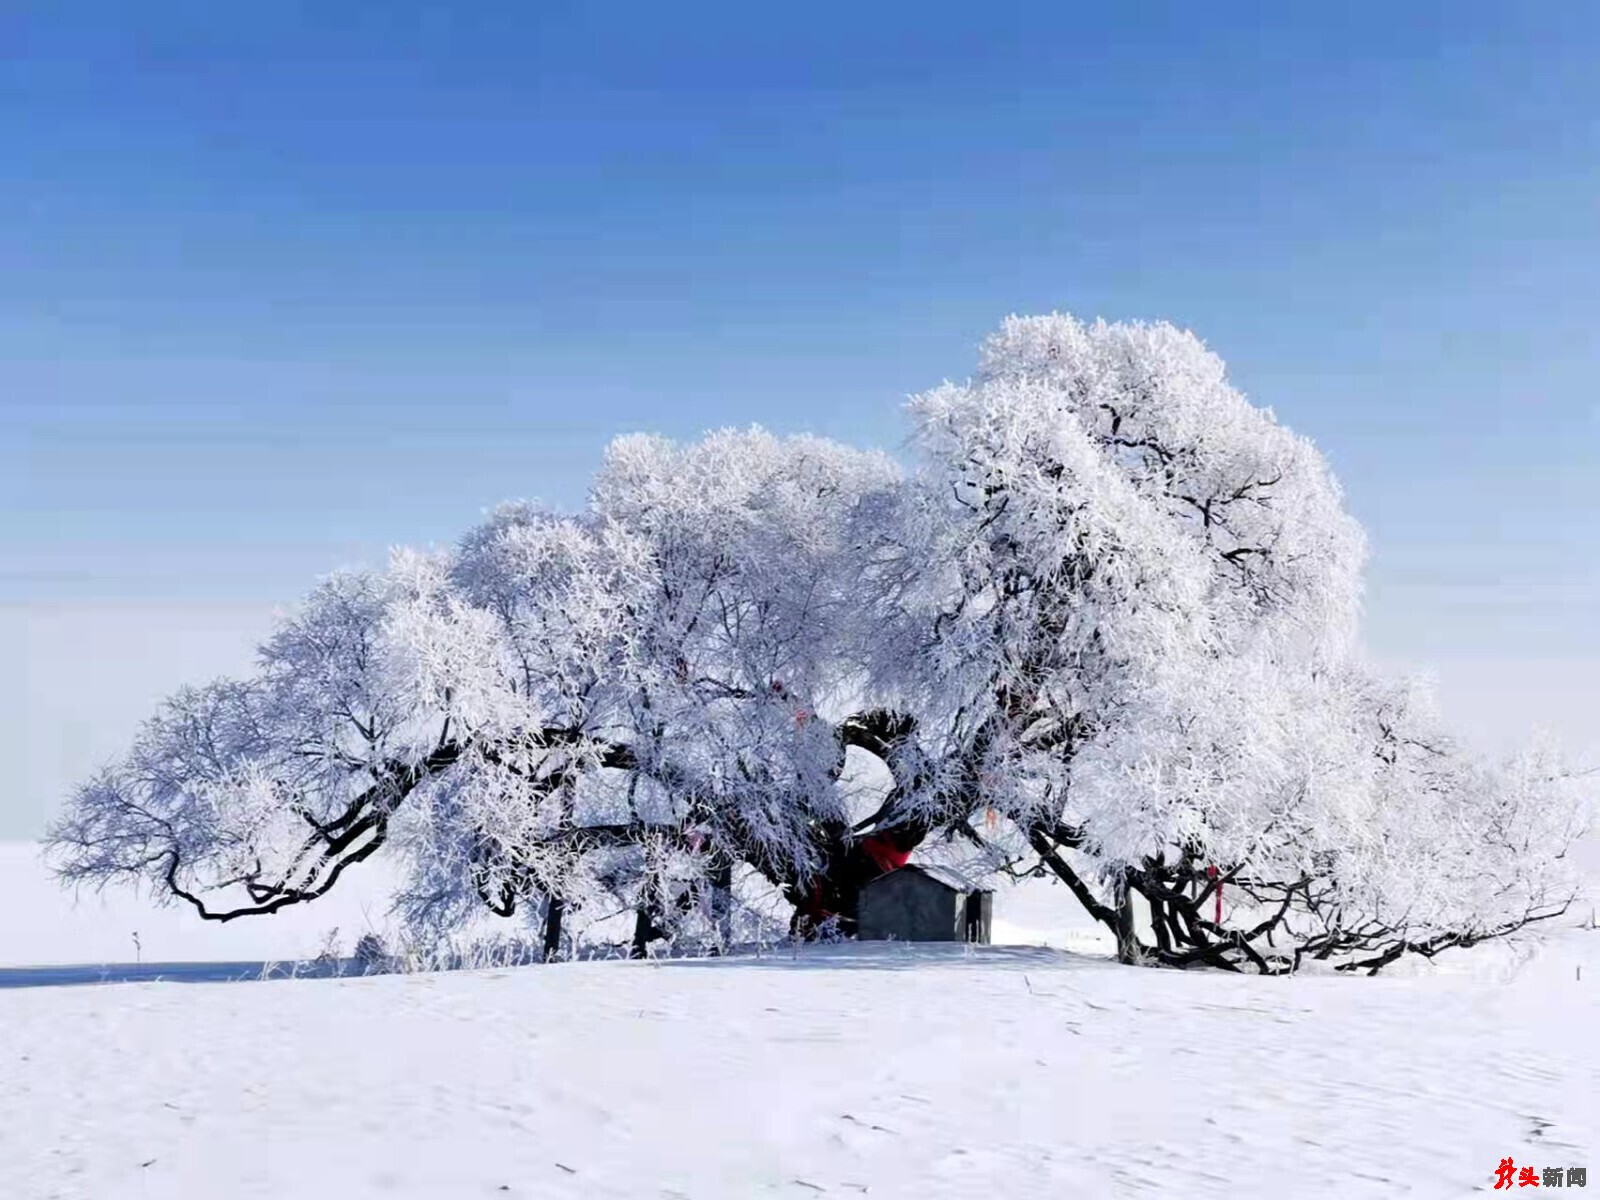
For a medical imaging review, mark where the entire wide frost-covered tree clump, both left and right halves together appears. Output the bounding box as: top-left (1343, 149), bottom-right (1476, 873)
top-left (53, 315), bottom-right (1578, 970)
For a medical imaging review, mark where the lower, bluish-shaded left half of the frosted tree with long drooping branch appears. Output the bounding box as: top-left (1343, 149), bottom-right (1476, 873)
top-left (53, 430), bottom-right (899, 952)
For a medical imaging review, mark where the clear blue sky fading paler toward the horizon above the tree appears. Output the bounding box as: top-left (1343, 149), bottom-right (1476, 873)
top-left (0, 0), bottom-right (1600, 837)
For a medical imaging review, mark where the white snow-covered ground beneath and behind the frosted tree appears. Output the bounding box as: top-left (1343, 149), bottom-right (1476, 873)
top-left (0, 848), bottom-right (1600, 1200)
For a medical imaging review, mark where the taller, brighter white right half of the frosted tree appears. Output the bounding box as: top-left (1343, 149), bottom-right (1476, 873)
top-left (857, 315), bottom-right (1574, 970)
